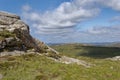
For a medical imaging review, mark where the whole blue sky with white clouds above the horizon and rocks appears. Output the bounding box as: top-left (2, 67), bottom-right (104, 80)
top-left (0, 0), bottom-right (120, 43)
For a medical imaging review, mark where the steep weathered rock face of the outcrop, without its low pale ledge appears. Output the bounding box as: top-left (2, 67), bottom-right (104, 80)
top-left (0, 12), bottom-right (57, 53)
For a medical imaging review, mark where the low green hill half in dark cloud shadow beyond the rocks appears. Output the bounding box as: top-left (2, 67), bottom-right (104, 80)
top-left (51, 44), bottom-right (120, 58)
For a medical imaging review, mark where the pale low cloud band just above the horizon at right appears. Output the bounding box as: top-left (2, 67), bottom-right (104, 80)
top-left (58, 25), bottom-right (120, 43)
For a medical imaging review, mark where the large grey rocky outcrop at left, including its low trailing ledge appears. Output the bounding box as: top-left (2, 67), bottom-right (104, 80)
top-left (0, 12), bottom-right (90, 67)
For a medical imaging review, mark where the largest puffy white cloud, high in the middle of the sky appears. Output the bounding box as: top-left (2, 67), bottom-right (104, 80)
top-left (23, 0), bottom-right (99, 33)
